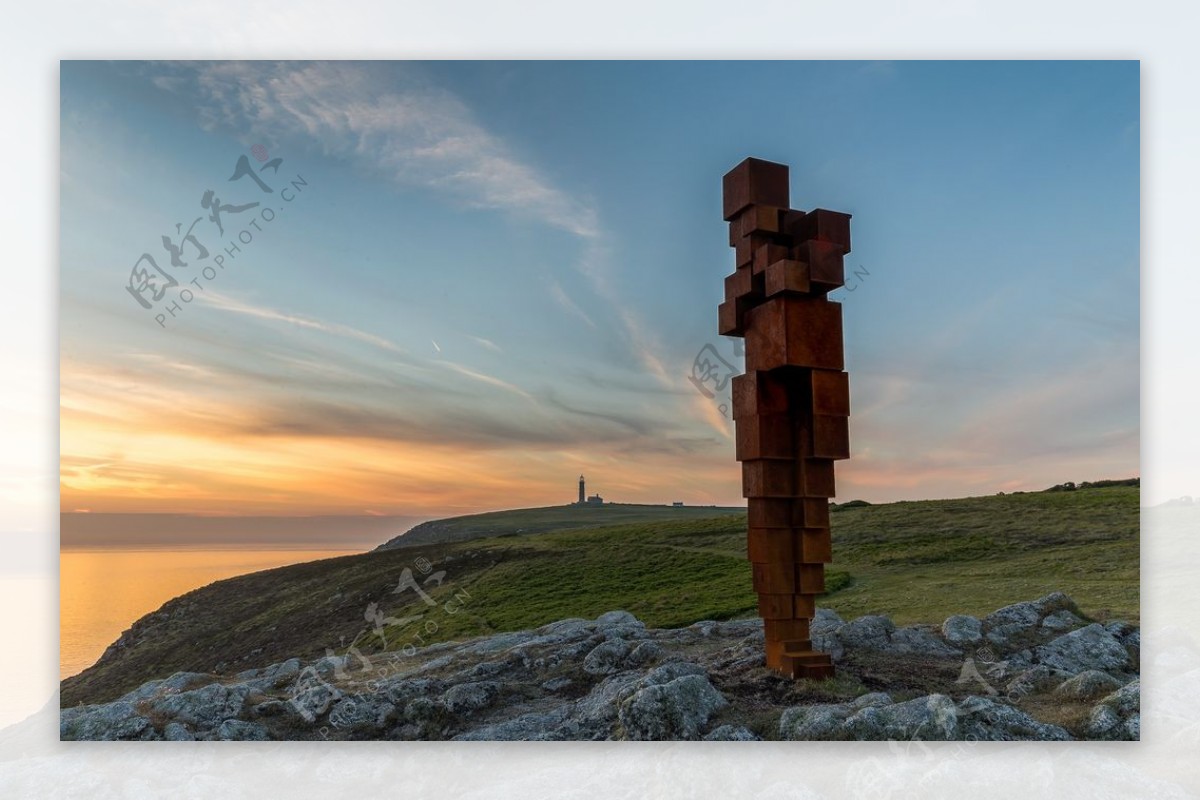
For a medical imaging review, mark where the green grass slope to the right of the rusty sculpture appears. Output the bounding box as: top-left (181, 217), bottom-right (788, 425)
top-left (826, 487), bottom-right (1139, 624)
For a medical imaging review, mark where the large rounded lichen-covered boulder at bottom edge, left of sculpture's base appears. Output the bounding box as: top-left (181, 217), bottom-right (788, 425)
top-left (618, 675), bottom-right (728, 740)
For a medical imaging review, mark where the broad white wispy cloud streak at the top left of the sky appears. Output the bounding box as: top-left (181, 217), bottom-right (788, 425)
top-left (152, 61), bottom-right (598, 237)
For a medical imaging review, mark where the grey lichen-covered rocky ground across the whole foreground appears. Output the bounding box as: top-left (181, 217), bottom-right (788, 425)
top-left (60, 592), bottom-right (1140, 740)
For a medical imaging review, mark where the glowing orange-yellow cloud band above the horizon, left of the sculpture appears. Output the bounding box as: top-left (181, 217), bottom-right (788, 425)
top-left (60, 363), bottom-right (740, 514)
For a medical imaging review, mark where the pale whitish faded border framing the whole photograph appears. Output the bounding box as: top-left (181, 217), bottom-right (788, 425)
top-left (0, 0), bottom-right (1200, 797)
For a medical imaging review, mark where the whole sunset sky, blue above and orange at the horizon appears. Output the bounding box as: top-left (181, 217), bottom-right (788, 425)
top-left (60, 61), bottom-right (1139, 517)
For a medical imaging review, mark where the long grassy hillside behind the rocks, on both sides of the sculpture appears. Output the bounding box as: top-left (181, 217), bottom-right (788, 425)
top-left (62, 487), bottom-right (1139, 705)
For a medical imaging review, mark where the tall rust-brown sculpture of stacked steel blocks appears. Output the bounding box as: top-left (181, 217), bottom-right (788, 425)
top-left (718, 158), bottom-right (850, 679)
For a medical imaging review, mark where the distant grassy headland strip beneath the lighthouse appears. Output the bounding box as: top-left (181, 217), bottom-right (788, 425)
top-left (377, 504), bottom-right (745, 550)
